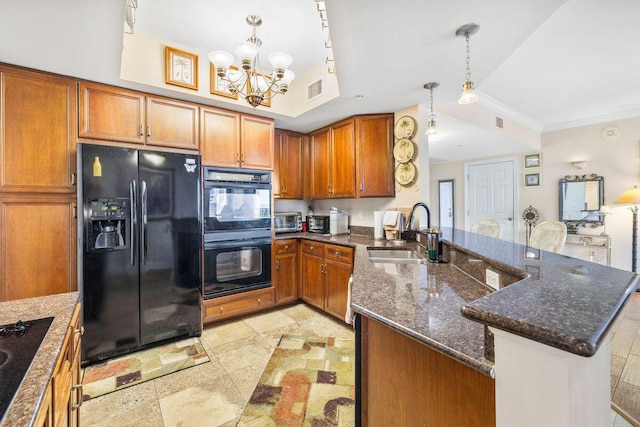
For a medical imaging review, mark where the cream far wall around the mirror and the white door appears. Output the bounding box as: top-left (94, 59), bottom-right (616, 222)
top-left (430, 118), bottom-right (640, 270)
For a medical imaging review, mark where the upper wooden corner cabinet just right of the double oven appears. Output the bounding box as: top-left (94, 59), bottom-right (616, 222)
top-left (272, 129), bottom-right (305, 199)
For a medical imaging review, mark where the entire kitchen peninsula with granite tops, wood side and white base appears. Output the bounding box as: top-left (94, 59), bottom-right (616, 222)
top-left (279, 230), bottom-right (639, 427)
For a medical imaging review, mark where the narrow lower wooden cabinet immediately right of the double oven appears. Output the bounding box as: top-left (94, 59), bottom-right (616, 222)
top-left (271, 239), bottom-right (298, 304)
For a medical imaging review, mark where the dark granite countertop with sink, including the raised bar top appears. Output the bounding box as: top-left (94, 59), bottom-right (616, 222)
top-left (276, 229), bottom-right (640, 375)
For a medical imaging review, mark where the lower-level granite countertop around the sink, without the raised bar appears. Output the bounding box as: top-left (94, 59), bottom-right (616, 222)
top-left (276, 233), bottom-right (493, 376)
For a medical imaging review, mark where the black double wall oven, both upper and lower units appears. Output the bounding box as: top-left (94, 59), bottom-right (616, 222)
top-left (202, 167), bottom-right (271, 299)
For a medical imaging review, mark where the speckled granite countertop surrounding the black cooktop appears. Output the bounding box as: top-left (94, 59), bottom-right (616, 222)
top-left (0, 292), bottom-right (79, 427)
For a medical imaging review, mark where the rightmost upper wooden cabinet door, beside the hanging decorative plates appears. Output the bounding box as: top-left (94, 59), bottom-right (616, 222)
top-left (356, 114), bottom-right (395, 197)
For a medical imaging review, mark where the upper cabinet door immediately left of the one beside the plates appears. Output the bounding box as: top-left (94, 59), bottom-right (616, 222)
top-left (330, 119), bottom-right (356, 198)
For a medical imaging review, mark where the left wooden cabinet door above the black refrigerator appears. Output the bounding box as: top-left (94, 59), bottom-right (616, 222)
top-left (78, 83), bottom-right (145, 144)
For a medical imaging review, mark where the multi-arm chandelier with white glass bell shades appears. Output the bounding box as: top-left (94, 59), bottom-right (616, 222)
top-left (209, 15), bottom-right (295, 108)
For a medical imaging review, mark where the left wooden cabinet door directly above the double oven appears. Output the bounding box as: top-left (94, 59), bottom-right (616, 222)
top-left (200, 108), bottom-right (240, 168)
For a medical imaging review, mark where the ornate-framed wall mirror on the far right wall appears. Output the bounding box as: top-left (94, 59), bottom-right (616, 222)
top-left (558, 174), bottom-right (604, 233)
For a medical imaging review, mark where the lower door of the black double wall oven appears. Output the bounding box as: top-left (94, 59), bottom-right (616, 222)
top-left (204, 238), bottom-right (271, 299)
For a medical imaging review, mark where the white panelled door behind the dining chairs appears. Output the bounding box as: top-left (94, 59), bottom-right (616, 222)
top-left (465, 157), bottom-right (518, 241)
